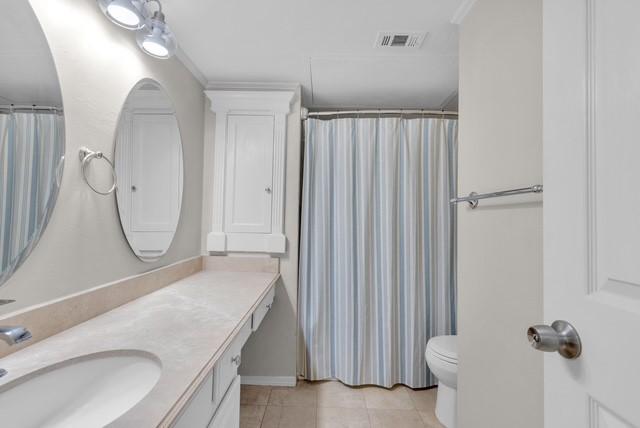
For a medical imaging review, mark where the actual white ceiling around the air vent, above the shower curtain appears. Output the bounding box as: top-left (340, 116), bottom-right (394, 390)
top-left (162, 0), bottom-right (469, 109)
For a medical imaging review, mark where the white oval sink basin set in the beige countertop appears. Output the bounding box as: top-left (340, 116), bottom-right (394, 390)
top-left (0, 351), bottom-right (162, 428)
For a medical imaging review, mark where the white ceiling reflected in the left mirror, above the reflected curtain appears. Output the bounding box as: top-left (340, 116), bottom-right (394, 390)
top-left (0, 0), bottom-right (62, 106)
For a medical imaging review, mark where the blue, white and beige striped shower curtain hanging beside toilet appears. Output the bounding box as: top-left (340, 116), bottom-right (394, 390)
top-left (298, 118), bottom-right (457, 388)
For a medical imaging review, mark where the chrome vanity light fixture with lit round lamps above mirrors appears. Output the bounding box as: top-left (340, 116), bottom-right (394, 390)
top-left (98, 0), bottom-right (178, 59)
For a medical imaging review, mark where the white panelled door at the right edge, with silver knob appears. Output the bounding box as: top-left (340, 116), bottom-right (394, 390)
top-left (543, 0), bottom-right (640, 428)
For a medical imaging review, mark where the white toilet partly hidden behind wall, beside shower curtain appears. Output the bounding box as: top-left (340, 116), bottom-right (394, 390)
top-left (425, 336), bottom-right (458, 428)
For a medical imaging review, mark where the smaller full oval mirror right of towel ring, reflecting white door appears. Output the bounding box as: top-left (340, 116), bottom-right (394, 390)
top-left (115, 79), bottom-right (183, 262)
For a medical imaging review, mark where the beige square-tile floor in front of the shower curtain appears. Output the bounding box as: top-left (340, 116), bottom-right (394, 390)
top-left (240, 382), bottom-right (443, 428)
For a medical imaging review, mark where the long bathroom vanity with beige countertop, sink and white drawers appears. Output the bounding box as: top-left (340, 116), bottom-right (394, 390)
top-left (0, 257), bottom-right (279, 428)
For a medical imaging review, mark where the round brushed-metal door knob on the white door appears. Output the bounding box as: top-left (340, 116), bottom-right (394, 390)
top-left (527, 320), bottom-right (582, 360)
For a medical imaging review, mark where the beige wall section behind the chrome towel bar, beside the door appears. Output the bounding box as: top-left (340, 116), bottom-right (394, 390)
top-left (458, 0), bottom-right (543, 428)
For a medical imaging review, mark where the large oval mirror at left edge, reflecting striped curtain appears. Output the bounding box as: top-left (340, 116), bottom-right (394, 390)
top-left (0, 0), bottom-right (65, 290)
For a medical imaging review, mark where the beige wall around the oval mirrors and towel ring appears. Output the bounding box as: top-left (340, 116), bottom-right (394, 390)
top-left (0, 0), bottom-right (204, 313)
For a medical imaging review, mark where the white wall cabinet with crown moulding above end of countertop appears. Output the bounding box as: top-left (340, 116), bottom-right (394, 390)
top-left (205, 91), bottom-right (295, 253)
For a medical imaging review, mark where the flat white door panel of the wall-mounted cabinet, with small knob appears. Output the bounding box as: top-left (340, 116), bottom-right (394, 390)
top-left (225, 115), bottom-right (274, 233)
